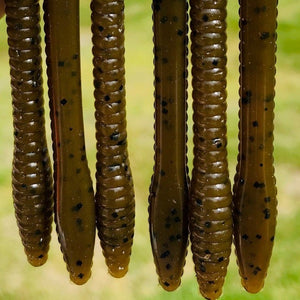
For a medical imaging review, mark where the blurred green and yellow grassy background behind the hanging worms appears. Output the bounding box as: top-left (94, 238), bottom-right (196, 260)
top-left (0, 0), bottom-right (300, 300)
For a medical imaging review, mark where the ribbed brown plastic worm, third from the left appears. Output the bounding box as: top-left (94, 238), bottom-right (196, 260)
top-left (91, 0), bottom-right (135, 277)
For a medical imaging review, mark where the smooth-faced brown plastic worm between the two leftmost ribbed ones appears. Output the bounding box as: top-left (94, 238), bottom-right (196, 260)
top-left (44, 0), bottom-right (95, 284)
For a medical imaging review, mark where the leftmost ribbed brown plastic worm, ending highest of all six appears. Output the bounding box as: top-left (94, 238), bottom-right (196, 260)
top-left (6, 0), bottom-right (53, 266)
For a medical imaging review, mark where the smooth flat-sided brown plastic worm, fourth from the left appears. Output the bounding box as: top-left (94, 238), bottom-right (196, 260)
top-left (149, 0), bottom-right (189, 291)
